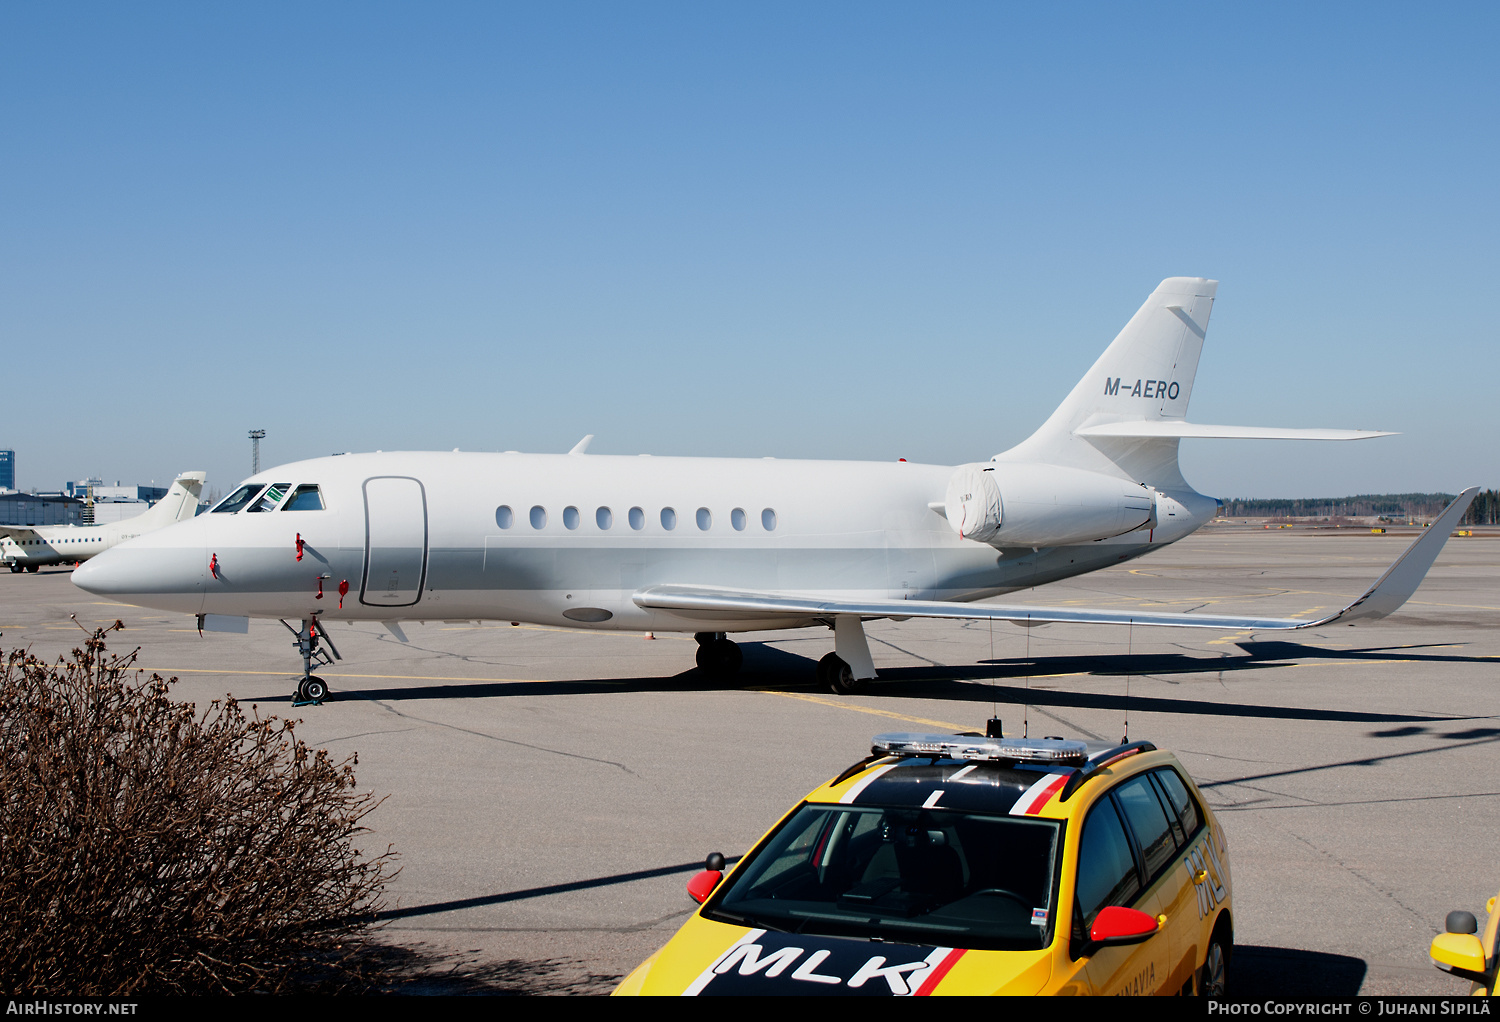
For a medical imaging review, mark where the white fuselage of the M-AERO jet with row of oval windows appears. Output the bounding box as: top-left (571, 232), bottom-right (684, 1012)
top-left (75, 452), bottom-right (1215, 632)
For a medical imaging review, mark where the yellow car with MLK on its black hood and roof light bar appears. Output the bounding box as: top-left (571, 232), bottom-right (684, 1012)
top-left (615, 720), bottom-right (1233, 995)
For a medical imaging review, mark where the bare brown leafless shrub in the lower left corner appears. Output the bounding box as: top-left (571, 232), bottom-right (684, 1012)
top-left (0, 621), bottom-right (393, 995)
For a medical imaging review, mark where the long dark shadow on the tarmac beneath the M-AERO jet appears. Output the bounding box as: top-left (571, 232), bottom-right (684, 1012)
top-left (252, 642), bottom-right (1494, 725)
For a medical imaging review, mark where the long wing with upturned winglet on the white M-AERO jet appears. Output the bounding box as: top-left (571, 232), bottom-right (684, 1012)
top-left (635, 486), bottom-right (1479, 632)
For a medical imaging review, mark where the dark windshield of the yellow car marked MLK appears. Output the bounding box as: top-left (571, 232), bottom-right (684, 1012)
top-left (704, 804), bottom-right (1061, 950)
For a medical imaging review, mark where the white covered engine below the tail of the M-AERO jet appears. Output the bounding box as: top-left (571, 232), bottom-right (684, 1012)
top-left (945, 462), bottom-right (1157, 546)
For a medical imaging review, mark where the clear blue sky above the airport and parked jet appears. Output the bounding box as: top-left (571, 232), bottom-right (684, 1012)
top-left (0, 3), bottom-right (1500, 497)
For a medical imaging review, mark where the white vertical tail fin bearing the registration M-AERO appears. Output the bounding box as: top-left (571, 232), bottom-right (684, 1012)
top-left (998, 276), bottom-right (1218, 489)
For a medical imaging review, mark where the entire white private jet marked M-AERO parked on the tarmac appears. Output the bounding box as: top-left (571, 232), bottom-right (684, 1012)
top-left (74, 278), bottom-right (1475, 701)
